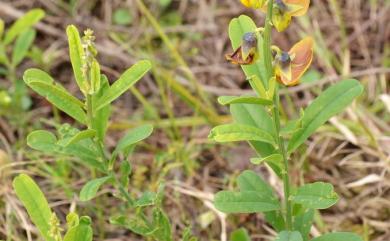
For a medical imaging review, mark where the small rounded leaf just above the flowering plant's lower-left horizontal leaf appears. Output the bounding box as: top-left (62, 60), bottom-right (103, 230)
top-left (237, 170), bottom-right (274, 197)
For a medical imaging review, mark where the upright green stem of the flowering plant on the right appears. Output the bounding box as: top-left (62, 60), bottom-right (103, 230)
top-left (263, 0), bottom-right (292, 230)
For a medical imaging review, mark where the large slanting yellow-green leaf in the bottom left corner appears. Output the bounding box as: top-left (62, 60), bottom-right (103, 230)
top-left (13, 174), bottom-right (54, 241)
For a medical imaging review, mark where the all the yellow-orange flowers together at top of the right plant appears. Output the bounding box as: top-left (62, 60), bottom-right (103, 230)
top-left (226, 0), bottom-right (313, 86)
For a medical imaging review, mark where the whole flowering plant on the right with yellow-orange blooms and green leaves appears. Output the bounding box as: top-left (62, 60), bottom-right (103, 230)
top-left (209, 0), bottom-right (363, 241)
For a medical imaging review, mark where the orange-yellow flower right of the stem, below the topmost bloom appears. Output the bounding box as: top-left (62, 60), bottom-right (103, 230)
top-left (275, 37), bottom-right (313, 86)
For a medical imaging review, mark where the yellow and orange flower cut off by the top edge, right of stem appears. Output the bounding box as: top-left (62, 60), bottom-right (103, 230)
top-left (262, 0), bottom-right (310, 32)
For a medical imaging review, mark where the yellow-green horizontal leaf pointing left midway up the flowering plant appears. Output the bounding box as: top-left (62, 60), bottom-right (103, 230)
top-left (209, 124), bottom-right (275, 144)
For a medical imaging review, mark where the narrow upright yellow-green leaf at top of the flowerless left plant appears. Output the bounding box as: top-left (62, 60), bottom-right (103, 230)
top-left (66, 25), bottom-right (87, 94)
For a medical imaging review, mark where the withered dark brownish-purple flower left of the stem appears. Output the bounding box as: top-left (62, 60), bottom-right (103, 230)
top-left (225, 32), bottom-right (258, 65)
